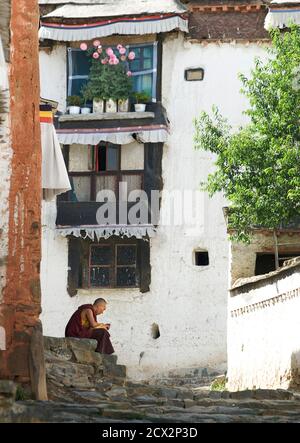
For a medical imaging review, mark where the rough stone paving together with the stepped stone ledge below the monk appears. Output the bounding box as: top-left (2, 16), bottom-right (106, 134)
top-left (0, 338), bottom-right (300, 423)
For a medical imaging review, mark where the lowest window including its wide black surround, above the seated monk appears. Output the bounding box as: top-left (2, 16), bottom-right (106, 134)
top-left (68, 236), bottom-right (151, 296)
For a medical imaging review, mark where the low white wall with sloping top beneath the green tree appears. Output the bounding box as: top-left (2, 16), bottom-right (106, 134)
top-left (228, 259), bottom-right (300, 391)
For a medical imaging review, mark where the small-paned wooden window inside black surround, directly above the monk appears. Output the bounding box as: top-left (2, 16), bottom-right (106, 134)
top-left (89, 242), bottom-right (138, 288)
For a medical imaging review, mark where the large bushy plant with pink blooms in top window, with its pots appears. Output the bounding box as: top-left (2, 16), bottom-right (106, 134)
top-left (80, 40), bottom-right (135, 112)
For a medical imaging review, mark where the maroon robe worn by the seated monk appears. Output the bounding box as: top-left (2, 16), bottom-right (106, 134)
top-left (65, 305), bottom-right (114, 354)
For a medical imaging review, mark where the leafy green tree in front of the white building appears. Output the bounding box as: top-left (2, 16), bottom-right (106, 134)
top-left (194, 26), bottom-right (300, 265)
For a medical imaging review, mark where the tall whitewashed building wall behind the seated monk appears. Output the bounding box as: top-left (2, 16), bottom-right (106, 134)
top-left (41, 35), bottom-right (264, 379)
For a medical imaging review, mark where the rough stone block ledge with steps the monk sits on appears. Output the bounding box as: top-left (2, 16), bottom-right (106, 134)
top-left (44, 337), bottom-right (126, 397)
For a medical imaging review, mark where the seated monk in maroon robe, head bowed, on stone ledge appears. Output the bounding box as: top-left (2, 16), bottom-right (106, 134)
top-left (65, 298), bottom-right (114, 354)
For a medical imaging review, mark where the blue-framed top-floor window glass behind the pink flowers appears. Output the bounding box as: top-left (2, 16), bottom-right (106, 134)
top-left (68, 42), bottom-right (157, 101)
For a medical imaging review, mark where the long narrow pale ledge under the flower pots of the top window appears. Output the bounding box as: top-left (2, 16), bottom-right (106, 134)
top-left (58, 112), bottom-right (155, 123)
